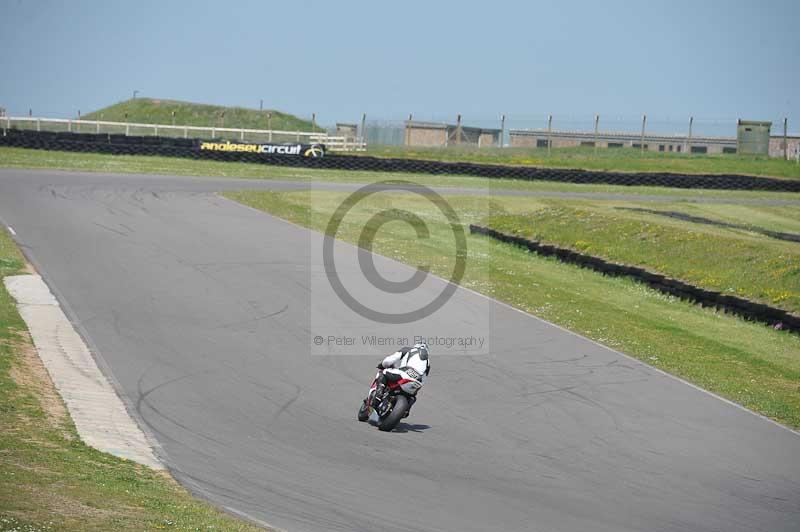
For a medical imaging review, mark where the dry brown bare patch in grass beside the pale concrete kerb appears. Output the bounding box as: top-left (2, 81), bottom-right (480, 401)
top-left (9, 331), bottom-right (72, 440)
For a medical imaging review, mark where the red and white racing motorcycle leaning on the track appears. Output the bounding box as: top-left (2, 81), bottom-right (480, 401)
top-left (358, 367), bottom-right (422, 432)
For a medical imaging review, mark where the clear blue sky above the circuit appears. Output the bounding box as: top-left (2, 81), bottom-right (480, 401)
top-left (0, 0), bottom-right (800, 130)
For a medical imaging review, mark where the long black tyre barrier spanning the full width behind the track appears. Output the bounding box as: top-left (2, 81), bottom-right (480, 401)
top-left (0, 129), bottom-right (800, 192)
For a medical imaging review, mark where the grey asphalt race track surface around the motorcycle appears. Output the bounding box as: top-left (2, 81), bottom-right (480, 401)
top-left (0, 170), bottom-right (800, 532)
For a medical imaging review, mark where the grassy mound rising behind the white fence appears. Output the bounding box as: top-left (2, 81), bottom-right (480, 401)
top-left (82, 98), bottom-right (323, 131)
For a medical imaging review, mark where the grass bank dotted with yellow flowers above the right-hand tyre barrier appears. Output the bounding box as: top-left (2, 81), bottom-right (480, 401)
top-left (482, 201), bottom-right (800, 312)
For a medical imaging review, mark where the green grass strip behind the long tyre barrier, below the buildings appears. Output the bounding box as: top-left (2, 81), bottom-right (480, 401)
top-left (361, 146), bottom-right (800, 179)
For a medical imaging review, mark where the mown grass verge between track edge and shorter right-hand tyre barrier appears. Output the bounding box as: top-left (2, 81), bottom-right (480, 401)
top-left (226, 191), bottom-right (800, 428)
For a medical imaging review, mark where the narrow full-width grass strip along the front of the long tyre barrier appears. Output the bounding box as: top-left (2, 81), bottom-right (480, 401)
top-left (0, 147), bottom-right (800, 201)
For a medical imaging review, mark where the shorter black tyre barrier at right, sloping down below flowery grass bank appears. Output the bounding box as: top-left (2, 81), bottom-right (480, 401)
top-left (469, 224), bottom-right (800, 332)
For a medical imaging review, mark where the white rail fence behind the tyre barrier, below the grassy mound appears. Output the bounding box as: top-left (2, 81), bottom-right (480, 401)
top-left (0, 116), bottom-right (366, 151)
